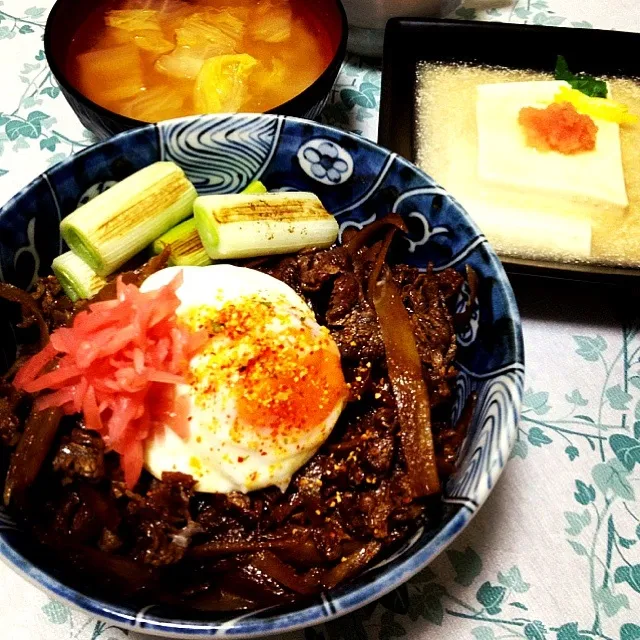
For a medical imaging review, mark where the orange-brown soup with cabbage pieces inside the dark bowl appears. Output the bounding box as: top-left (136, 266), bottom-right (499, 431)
top-left (67, 0), bottom-right (335, 122)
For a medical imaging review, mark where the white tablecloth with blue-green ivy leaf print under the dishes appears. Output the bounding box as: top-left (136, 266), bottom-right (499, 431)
top-left (0, 0), bottom-right (640, 640)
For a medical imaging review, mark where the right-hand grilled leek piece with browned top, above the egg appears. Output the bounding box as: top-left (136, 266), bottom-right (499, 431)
top-left (193, 192), bottom-right (338, 260)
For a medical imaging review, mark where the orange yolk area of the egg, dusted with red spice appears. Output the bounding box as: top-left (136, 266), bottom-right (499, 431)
top-left (185, 296), bottom-right (348, 437)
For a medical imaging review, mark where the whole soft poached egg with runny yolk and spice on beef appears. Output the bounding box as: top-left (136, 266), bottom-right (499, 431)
top-left (140, 264), bottom-right (348, 493)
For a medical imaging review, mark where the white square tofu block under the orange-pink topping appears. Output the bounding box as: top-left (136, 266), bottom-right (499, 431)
top-left (476, 81), bottom-right (629, 220)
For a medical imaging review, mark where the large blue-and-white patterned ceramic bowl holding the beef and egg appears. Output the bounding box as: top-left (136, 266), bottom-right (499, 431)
top-left (0, 115), bottom-right (524, 638)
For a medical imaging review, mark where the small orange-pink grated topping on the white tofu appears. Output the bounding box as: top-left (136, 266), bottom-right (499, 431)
top-left (518, 102), bottom-right (598, 155)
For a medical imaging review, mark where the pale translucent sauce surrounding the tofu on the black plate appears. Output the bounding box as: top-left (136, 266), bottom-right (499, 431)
top-left (415, 63), bottom-right (640, 267)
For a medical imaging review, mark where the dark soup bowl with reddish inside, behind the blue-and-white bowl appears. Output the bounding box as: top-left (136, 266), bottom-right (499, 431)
top-left (44, 0), bottom-right (348, 139)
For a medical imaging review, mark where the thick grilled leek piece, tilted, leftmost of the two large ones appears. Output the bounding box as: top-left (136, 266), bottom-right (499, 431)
top-left (60, 162), bottom-right (197, 277)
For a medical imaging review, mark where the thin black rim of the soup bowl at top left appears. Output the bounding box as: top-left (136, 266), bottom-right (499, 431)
top-left (43, 0), bottom-right (349, 130)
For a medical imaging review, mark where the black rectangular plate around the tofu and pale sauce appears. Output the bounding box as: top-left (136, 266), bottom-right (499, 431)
top-left (378, 18), bottom-right (640, 283)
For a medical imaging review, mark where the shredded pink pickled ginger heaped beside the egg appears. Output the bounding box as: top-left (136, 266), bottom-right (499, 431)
top-left (13, 275), bottom-right (206, 489)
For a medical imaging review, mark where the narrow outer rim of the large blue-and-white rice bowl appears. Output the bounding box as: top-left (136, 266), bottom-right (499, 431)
top-left (0, 113), bottom-right (525, 639)
